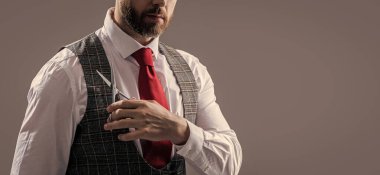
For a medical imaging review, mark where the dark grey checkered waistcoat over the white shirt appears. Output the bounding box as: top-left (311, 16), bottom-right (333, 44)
top-left (66, 33), bottom-right (198, 175)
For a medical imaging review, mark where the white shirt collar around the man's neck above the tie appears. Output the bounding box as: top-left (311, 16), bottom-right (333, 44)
top-left (104, 7), bottom-right (159, 60)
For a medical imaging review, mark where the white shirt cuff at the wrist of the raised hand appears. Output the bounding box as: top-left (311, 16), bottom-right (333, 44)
top-left (174, 121), bottom-right (204, 161)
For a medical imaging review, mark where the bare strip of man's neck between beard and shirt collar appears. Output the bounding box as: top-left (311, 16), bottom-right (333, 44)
top-left (112, 9), bottom-right (154, 46)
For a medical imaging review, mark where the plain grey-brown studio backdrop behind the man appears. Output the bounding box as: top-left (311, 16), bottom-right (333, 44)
top-left (0, 0), bottom-right (380, 175)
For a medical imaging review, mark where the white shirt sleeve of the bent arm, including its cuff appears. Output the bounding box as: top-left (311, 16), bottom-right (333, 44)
top-left (176, 51), bottom-right (242, 175)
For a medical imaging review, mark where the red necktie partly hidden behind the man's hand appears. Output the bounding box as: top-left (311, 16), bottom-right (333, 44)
top-left (132, 48), bottom-right (172, 169)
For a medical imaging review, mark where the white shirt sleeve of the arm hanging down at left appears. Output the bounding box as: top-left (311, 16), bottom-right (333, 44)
top-left (11, 55), bottom-right (75, 175)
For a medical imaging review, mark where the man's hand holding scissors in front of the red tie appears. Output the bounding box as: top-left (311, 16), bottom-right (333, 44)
top-left (104, 99), bottom-right (190, 145)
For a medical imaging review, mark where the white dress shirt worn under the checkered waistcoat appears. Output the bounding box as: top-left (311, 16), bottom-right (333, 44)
top-left (11, 8), bottom-right (242, 175)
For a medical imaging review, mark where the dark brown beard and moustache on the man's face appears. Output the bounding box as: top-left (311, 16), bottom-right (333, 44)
top-left (122, 5), bottom-right (170, 37)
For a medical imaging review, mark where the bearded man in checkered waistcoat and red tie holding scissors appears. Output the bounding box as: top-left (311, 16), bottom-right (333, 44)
top-left (11, 0), bottom-right (242, 175)
